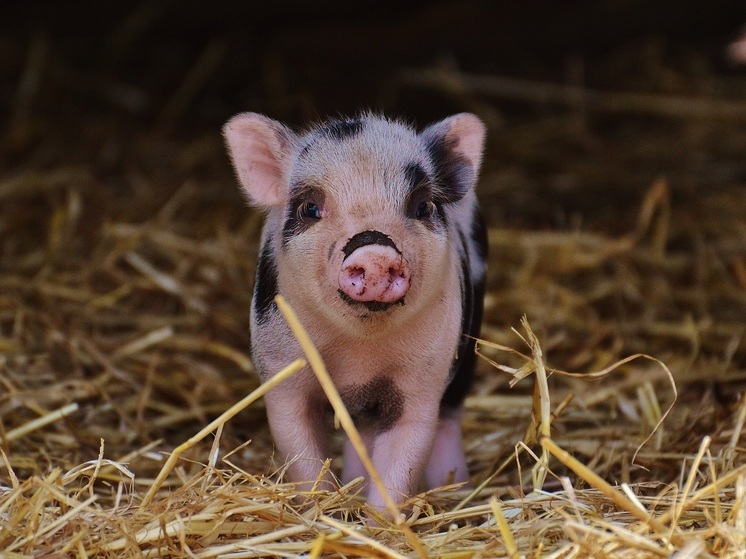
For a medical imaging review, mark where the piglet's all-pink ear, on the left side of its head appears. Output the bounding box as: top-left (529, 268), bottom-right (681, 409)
top-left (223, 113), bottom-right (296, 209)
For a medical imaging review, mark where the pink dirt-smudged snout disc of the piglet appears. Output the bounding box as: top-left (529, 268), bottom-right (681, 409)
top-left (339, 244), bottom-right (412, 303)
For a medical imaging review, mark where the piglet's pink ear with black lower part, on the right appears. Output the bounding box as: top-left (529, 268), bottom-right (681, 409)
top-left (422, 113), bottom-right (486, 203)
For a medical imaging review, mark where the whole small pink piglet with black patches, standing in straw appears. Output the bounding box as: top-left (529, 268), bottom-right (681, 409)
top-left (224, 113), bottom-right (486, 507)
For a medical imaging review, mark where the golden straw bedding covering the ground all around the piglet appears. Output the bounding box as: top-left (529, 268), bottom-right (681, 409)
top-left (0, 3), bottom-right (746, 559)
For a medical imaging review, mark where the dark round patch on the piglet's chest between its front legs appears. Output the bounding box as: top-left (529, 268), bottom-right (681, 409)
top-left (340, 377), bottom-right (405, 432)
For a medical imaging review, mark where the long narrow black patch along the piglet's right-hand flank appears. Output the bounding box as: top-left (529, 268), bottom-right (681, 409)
top-left (440, 230), bottom-right (484, 416)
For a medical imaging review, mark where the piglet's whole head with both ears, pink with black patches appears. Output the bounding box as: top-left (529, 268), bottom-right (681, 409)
top-left (224, 113), bottom-right (484, 329)
